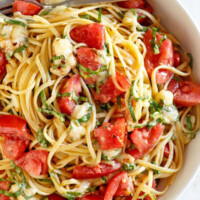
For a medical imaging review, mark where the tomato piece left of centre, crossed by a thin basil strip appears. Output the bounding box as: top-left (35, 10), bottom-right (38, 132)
top-left (58, 75), bottom-right (82, 114)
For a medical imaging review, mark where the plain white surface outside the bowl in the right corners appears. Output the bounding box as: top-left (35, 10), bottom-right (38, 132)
top-left (177, 0), bottom-right (200, 200)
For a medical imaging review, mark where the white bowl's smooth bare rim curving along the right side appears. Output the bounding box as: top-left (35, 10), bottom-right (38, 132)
top-left (149, 0), bottom-right (200, 200)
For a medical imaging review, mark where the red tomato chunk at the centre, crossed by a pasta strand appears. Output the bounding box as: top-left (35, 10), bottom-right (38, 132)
top-left (94, 72), bottom-right (130, 103)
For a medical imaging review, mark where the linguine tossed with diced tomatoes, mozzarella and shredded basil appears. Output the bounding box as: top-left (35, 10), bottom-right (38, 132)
top-left (0, 0), bottom-right (200, 200)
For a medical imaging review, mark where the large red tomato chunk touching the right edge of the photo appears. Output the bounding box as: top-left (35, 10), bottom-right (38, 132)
top-left (168, 79), bottom-right (200, 107)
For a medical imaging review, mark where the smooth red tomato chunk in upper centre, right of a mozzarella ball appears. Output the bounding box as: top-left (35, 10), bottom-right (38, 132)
top-left (70, 23), bottom-right (105, 49)
